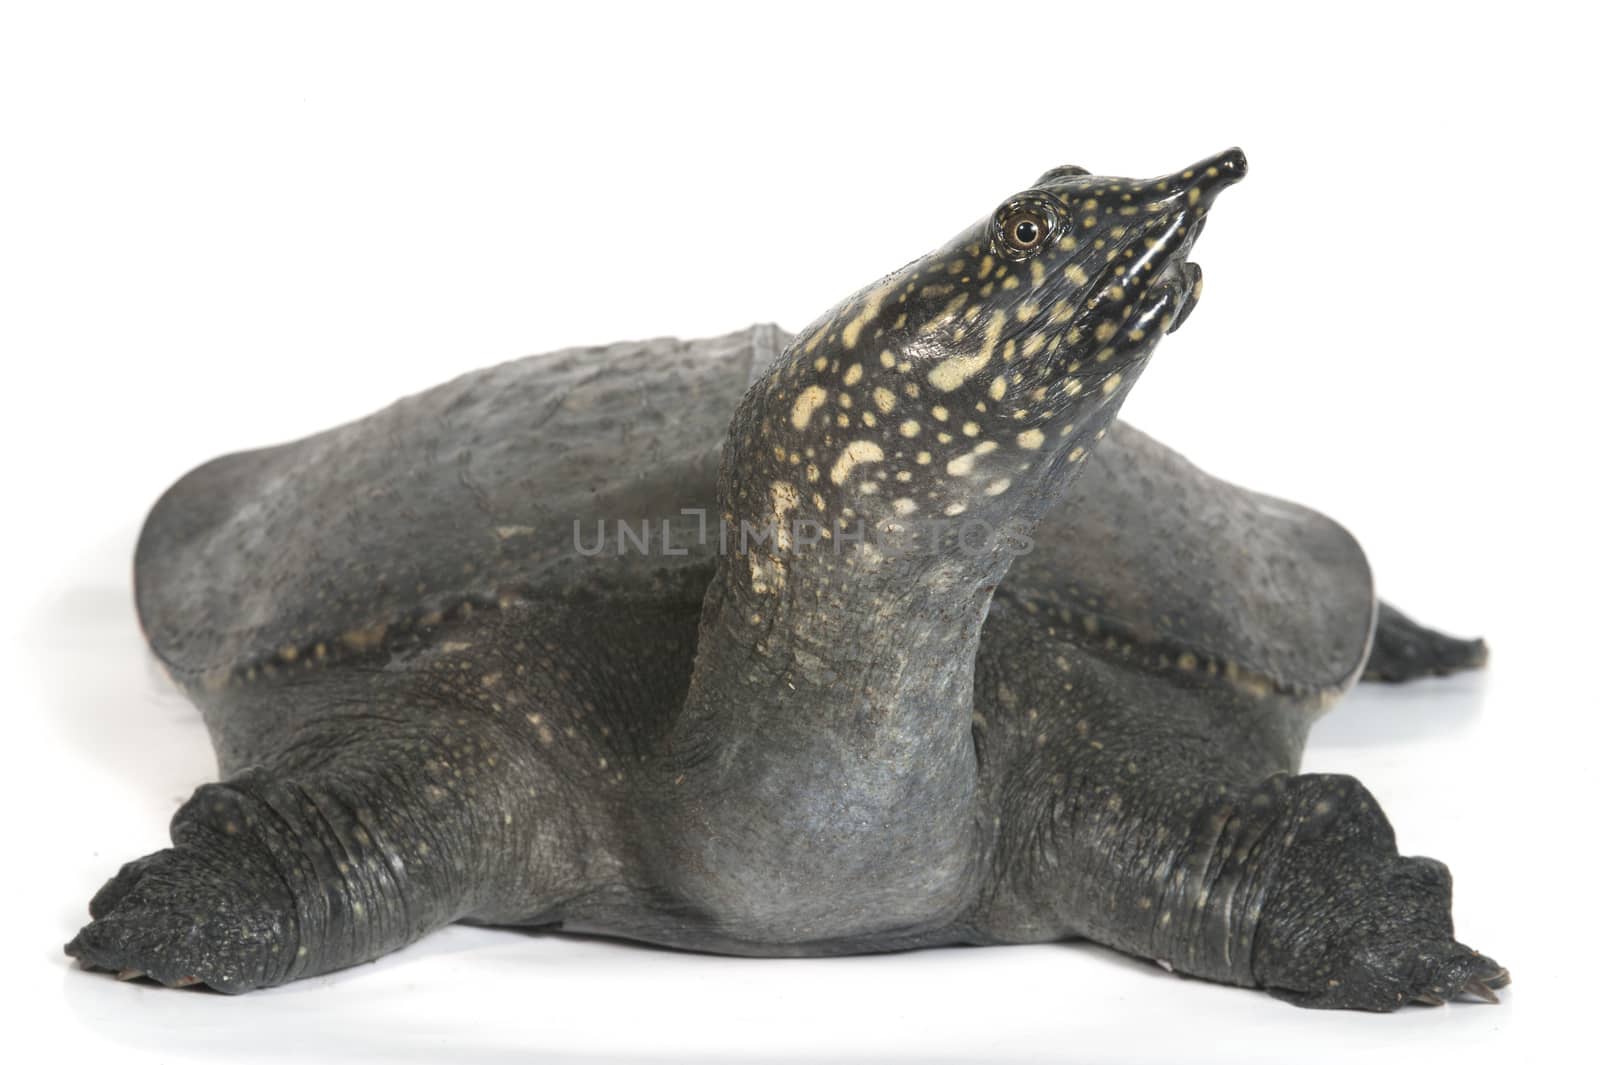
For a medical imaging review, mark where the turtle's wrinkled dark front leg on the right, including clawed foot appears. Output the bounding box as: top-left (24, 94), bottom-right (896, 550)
top-left (982, 667), bottom-right (1509, 1011)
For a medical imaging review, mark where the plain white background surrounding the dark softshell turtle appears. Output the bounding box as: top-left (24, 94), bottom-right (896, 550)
top-left (0, 2), bottom-right (1600, 1062)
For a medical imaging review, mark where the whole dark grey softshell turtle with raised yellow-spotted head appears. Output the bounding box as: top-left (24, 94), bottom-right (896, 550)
top-left (67, 150), bottom-right (1509, 1011)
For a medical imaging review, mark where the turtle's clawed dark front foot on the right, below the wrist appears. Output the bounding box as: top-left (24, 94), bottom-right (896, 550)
top-left (1251, 780), bottom-right (1510, 1012)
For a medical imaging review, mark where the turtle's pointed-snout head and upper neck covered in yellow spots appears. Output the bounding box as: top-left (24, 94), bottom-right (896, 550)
top-left (734, 149), bottom-right (1245, 556)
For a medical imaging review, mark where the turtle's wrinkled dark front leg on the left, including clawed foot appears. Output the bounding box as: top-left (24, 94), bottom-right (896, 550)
top-left (66, 676), bottom-right (563, 993)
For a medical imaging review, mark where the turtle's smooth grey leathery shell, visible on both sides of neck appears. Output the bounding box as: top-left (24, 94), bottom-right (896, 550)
top-left (136, 326), bottom-right (1376, 722)
